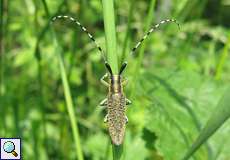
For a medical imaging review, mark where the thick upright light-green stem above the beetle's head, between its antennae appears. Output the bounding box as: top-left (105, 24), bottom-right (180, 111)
top-left (102, 0), bottom-right (118, 74)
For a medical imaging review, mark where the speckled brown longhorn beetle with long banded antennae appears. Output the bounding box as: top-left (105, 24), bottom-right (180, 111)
top-left (51, 15), bottom-right (180, 145)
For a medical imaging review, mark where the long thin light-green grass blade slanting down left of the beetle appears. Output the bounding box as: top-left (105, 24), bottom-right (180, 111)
top-left (51, 28), bottom-right (84, 160)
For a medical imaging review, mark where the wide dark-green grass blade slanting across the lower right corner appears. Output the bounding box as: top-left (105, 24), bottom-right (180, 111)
top-left (183, 87), bottom-right (230, 160)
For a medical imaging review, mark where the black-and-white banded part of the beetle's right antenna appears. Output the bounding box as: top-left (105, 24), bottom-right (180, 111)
top-left (131, 19), bottom-right (180, 54)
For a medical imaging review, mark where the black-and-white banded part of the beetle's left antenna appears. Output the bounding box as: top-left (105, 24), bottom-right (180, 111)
top-left (51, 15), bottom-right (106, 61)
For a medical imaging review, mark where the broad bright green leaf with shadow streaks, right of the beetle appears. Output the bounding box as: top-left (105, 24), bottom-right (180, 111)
top-left (141, 69), bottom-right (229, 160)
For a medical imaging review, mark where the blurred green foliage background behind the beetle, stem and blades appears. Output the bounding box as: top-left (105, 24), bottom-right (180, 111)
top-left (0, 0), bottom-right (230, 160)
